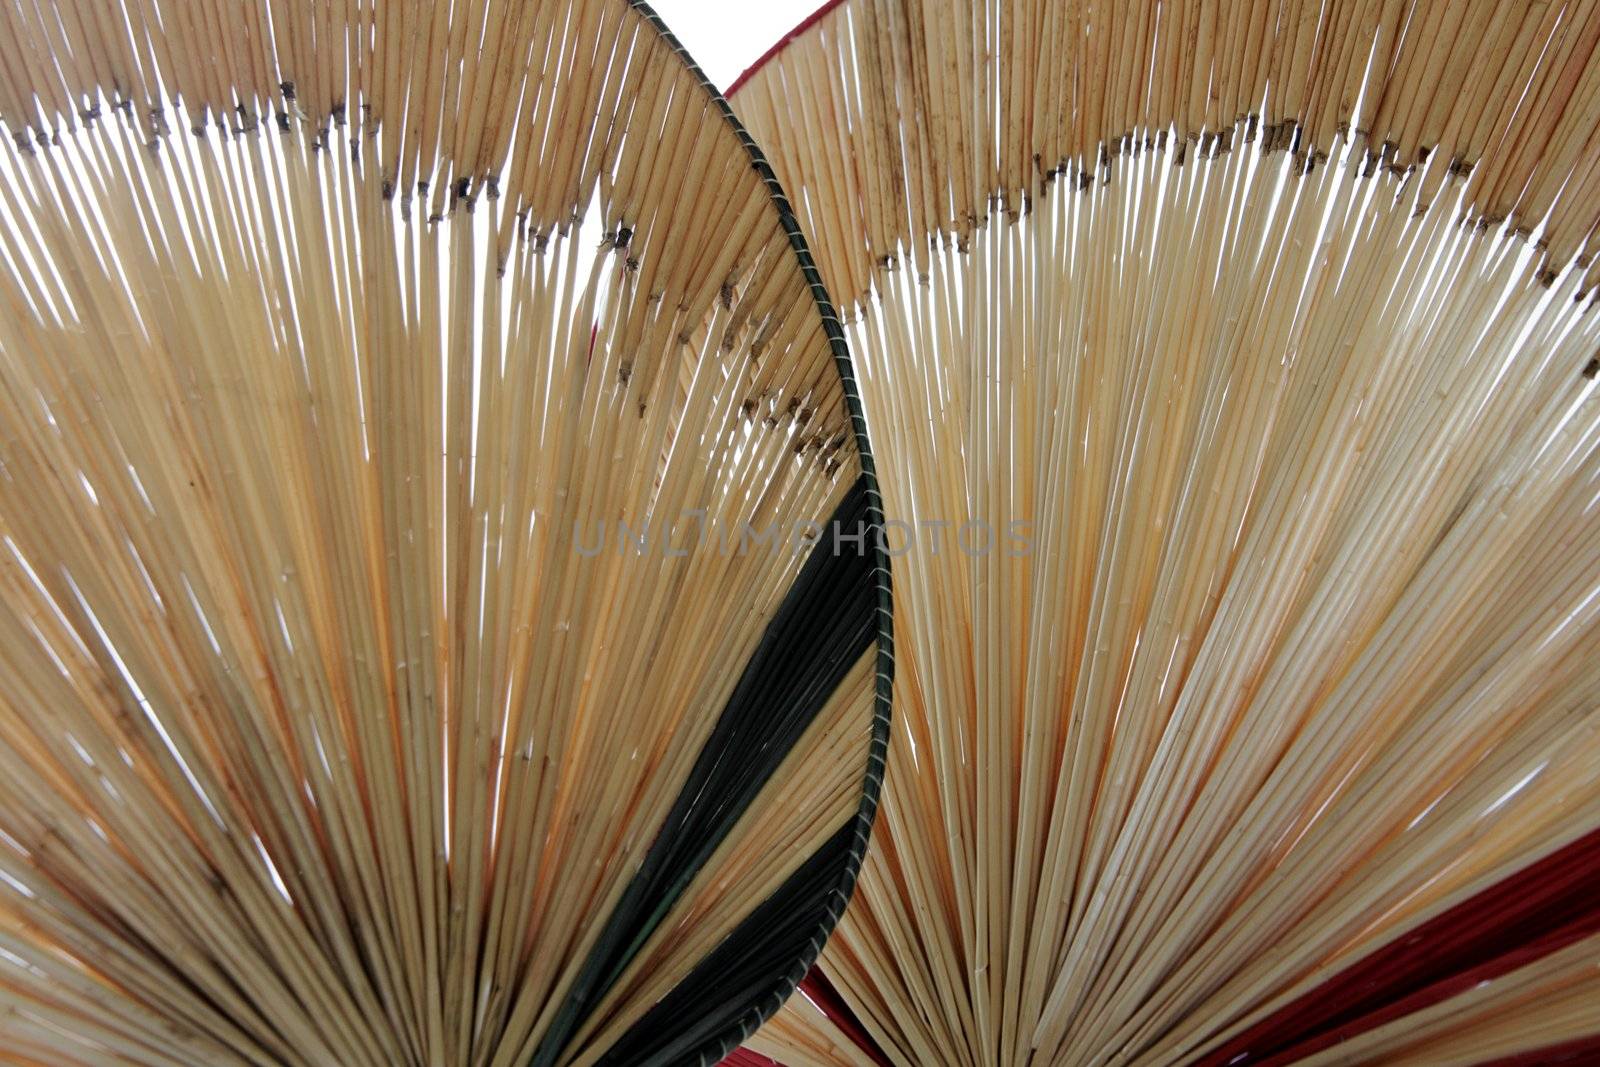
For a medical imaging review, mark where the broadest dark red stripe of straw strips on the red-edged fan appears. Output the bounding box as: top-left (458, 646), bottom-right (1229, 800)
top-left (1197, 830), bottom-right (1600, 1067)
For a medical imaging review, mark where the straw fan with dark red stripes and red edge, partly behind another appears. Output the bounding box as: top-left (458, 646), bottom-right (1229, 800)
top-left (730, 0), bottom-right (1600, 1067)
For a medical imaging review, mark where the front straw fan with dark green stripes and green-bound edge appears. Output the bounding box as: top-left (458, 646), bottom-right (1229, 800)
top-left (0, 0), bottom-right (891, 1067)
